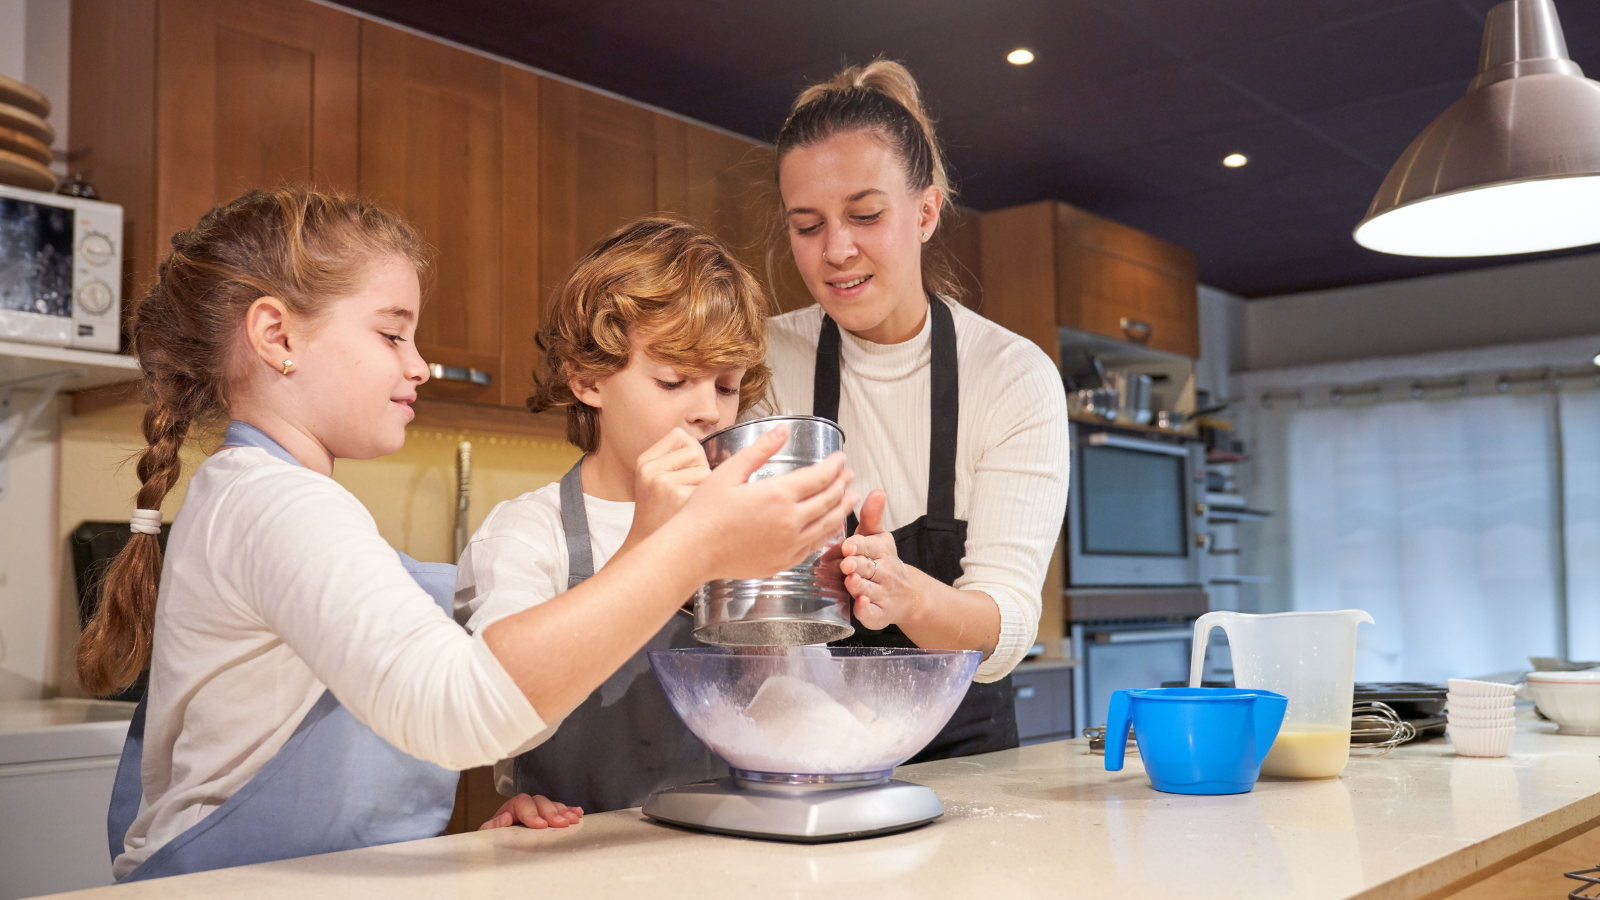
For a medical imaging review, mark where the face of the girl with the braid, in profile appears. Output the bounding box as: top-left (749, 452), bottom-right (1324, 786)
top-left (282, 256), bottom-right (427, 460)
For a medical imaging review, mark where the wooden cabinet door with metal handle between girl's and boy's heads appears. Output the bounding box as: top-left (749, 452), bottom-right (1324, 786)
top-left (360, 21), bottom-right (541, 407)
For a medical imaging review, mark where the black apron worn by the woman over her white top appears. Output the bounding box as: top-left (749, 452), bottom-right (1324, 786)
top-left (811, 296), bottom-right (1018, 762)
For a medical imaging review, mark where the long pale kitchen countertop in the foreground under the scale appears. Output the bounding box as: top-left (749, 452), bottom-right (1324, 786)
top-left (34, 711), bottom-right (1600, 900)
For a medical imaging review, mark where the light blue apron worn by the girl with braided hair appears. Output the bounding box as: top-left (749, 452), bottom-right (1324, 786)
top-left (106, 421), bottom-right (461, 882)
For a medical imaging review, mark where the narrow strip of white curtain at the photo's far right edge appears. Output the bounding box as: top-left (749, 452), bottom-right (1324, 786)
top-left (1562, 391), bottom-right (1600, 661)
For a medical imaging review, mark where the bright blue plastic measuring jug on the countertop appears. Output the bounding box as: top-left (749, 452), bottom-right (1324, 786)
top-left (1106, 687), bottom-right (1290, 794)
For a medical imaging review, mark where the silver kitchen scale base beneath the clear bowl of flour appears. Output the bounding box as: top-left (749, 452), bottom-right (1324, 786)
top-left (643, 769), bottom-right (944, 844)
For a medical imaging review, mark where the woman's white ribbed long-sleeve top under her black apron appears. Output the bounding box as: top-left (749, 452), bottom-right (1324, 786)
top-left (766, 304), bottom-right (1070, 682)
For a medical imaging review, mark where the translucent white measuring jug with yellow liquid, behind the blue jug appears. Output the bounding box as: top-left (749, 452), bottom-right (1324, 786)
top-left (1189, 610), bottom-right (1373, 778)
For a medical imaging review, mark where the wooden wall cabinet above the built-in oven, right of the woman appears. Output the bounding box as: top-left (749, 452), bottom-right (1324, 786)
top-left (982, 202), bottom-right (1200, 359)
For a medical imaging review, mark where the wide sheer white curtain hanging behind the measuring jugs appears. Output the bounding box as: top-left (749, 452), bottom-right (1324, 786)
top-left (1285, 394), bottom-right (1561, 681)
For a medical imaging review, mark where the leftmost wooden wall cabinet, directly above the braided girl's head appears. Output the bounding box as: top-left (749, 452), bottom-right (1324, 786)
top-left (69, 0), bottom-right (360, 317)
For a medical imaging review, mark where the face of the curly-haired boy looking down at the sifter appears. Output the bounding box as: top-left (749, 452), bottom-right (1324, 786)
top-left (573, 330), bottom-right (744, 468)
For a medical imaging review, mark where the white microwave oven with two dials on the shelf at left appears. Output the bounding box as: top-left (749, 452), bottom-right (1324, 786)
top-left (0, 184), bottom-right (122, 352)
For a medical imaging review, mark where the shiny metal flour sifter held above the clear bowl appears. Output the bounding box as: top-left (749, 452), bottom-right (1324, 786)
top-left (694, 416), bottom-right (854, 647)
